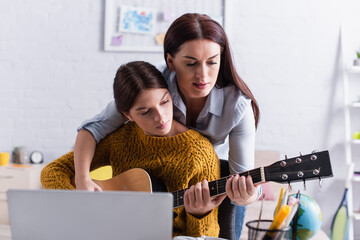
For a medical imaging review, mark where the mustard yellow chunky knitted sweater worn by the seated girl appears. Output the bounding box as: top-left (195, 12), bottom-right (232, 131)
top-left (41, 122), bottom-right (220, 237)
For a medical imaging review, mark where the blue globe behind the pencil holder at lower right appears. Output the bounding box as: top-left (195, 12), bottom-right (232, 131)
top-left (291, 194), bottom-right (322, 240)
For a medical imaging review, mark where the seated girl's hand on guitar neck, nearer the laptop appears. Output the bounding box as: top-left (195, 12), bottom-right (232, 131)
top-left (184, 180), bottom-right (226, 218)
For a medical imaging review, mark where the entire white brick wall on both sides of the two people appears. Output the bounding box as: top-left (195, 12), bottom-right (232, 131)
top-left (0, 0), bottom-right (358, 236)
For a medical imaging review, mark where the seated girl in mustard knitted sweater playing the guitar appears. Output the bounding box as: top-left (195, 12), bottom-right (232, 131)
top-left (41, 62), bottom-right (225, 237)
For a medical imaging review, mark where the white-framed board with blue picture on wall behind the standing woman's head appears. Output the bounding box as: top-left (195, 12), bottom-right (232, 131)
top-left (104, 0), bottom-right (226, 52)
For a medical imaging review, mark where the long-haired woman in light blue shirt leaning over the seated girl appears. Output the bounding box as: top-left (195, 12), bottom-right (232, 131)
top-left (75, 14), bottom-right (260, 239)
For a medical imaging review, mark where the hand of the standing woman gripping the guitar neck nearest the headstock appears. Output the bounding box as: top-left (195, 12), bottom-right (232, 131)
top-left (226, 174), bottom-right (258, 206)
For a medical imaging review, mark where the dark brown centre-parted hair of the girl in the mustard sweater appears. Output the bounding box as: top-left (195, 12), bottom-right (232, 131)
top-left (113, 61), bottom-right (168, 113)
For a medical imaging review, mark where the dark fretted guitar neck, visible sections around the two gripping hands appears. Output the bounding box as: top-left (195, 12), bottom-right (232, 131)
top-left (172, 167), bottom-right (266, 208)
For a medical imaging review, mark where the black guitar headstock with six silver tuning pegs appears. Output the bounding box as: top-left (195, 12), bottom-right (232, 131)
top-left (264, 151), bottom-right (333, 183)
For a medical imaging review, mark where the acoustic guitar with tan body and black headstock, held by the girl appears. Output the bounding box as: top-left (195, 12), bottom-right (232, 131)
top-left (93, 151), bottom-right (333, 208)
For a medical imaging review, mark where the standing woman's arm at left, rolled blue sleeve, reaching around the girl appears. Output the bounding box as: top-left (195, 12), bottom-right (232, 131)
top-left (74, 101), bottom-right (126, 191)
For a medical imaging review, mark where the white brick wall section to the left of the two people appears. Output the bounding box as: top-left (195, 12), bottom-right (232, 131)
top-left (0, 0), bottom-right (162, 162)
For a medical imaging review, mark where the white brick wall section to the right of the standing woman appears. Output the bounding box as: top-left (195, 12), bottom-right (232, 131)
top-left (229, 0), bottom-right (360, 236)
